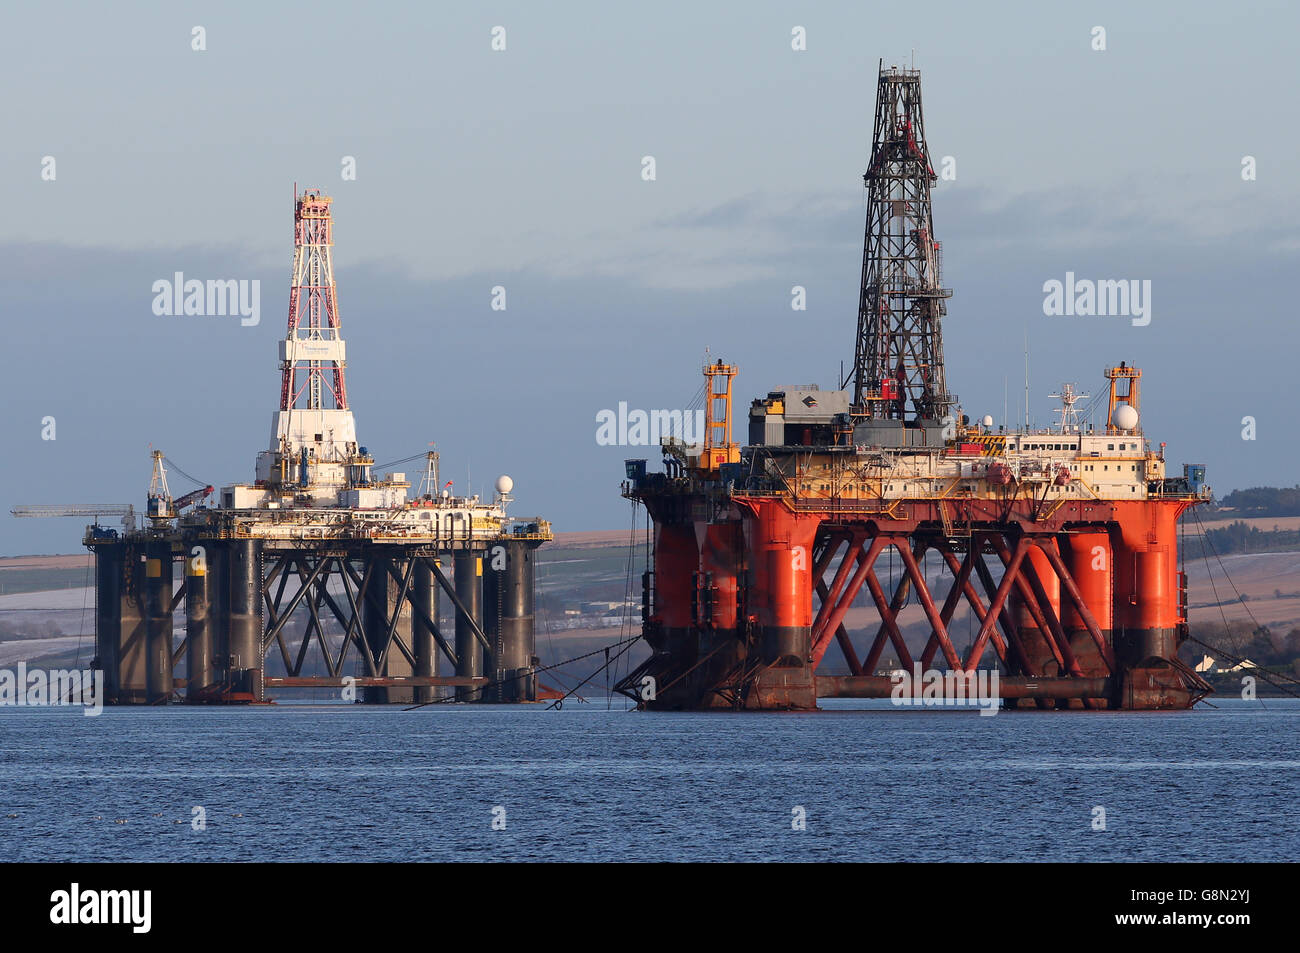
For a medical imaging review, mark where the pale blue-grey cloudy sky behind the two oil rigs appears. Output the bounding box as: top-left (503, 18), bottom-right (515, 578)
top-left (0, 3), bottom-right (1300, 555)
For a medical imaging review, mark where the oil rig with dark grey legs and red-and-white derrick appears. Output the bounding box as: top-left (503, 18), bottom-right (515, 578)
top-left (14, 190), bottom-right (551, 705)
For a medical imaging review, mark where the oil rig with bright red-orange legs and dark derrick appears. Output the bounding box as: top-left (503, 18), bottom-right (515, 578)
top-left (619, 68), bottom-right (1210, 710)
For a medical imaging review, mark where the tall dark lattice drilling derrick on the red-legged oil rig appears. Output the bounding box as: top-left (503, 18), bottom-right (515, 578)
top-left (850, 68), bottom-right (954, 426)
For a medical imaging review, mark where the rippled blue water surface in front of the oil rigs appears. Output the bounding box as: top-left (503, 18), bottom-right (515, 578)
top-left (0, 699), bottom-right (1300, 861)
